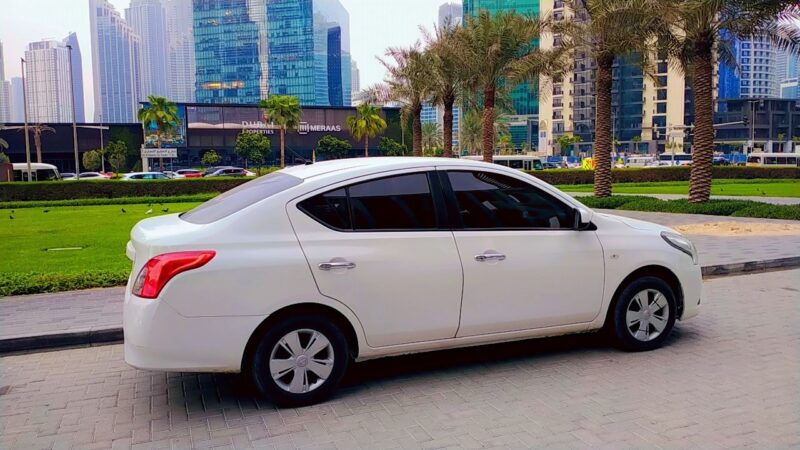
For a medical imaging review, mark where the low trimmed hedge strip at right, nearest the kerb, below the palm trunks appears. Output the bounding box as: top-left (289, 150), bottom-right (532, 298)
top-left (576, 195), bottom-right (800, 220)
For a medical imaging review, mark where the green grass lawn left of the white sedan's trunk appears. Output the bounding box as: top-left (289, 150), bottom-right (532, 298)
top-left (0, 203), bottom-right (198, 296)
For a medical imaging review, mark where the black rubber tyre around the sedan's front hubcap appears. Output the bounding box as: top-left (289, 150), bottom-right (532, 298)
top-left (608, 276), bottom-right (678, 352)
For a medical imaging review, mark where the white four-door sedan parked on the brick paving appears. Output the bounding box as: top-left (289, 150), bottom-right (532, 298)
top-left (124, 158), bottom-right (701, 405)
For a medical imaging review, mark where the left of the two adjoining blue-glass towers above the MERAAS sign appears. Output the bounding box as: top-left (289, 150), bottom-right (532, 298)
top-left (193, 0), bottom-right (267, 103)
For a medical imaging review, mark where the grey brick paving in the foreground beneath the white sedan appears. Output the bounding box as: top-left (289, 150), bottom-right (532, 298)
top-left (0, 270), bottom-right (800, 449)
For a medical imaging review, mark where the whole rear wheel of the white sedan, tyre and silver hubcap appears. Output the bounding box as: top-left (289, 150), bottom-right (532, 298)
top-left (251, 315), bottom-right (349, 407)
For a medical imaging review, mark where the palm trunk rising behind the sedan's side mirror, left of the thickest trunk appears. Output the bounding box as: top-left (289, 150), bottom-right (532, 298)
top-left (594, 55), bottom-right (614, 197)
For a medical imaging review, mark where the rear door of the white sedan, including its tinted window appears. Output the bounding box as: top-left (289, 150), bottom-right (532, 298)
top-left (287, 170), bottom-right (462, 347)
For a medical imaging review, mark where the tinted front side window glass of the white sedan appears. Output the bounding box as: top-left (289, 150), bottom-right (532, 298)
top-left (447, 171), bottom-right (574, 229)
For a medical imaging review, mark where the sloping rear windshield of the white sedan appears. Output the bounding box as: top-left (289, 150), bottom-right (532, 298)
top-left (181, 172), bottom-right (303, 225)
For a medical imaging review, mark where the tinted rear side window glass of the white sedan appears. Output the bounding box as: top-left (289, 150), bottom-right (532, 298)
top-left (298, 173), bottom-right (437, 231)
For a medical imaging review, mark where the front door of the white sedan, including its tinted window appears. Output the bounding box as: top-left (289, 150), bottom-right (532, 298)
top-left (441, 170), bottom-right (604, 337)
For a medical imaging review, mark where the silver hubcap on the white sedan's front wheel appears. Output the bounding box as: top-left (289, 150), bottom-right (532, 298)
top-left (625, 289), bottom-right (669, 342)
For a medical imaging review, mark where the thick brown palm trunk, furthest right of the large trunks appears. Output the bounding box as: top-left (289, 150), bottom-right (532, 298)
top-left (689, 39), bottom-right (714, 203)
